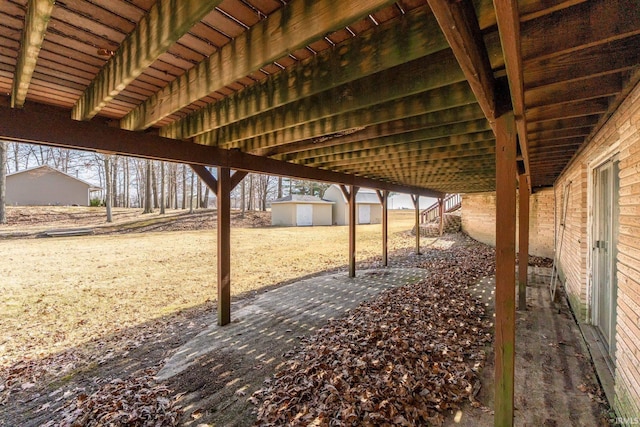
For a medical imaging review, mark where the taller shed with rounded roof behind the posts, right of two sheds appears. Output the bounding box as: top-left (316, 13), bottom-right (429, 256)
top-left (324, 184), bottom-right (382, 225)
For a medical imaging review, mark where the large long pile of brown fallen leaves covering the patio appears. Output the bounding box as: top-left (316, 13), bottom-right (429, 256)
top-left (250, 244), bottom-right (494, 426)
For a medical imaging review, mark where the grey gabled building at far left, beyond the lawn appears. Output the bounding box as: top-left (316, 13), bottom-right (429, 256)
top-left (6, 165), bottom-right (98, 206)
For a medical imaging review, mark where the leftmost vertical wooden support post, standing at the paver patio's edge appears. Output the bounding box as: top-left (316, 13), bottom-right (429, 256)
top-left (217, 167), bottom-right (231, 326)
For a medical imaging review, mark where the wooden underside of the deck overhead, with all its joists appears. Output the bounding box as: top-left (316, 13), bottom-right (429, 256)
top-left (0, 0), bottom-right (640, 197)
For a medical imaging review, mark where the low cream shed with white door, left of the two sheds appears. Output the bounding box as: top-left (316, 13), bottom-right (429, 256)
top-left (271, 194), bottom-right (333, 227)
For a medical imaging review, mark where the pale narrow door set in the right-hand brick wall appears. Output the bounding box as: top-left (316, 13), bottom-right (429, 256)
top-left (592, 161), bottom-right (618, 359)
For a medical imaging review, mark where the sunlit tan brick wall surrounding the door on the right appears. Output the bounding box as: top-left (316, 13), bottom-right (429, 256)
top-left (555, 81), bottom-right (640, 419)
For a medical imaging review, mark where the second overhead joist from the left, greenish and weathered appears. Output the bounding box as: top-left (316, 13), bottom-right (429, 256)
top-left (71, 0), bottom-right (222, 120)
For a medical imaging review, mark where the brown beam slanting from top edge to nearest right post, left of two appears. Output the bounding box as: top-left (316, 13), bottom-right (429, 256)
top-left (428, 0), bottom-right (502, 124)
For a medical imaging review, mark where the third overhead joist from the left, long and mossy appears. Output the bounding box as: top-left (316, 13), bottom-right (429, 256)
top-left (120, 0), bottom-right (400, 129)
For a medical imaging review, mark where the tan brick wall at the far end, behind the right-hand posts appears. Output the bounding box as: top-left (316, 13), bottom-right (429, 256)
top-left (462, 189), bottom-right (554, 258)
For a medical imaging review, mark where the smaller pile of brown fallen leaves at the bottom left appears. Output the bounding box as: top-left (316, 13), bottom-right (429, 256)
top-left (48, 369), bottom-right (182, 427)
